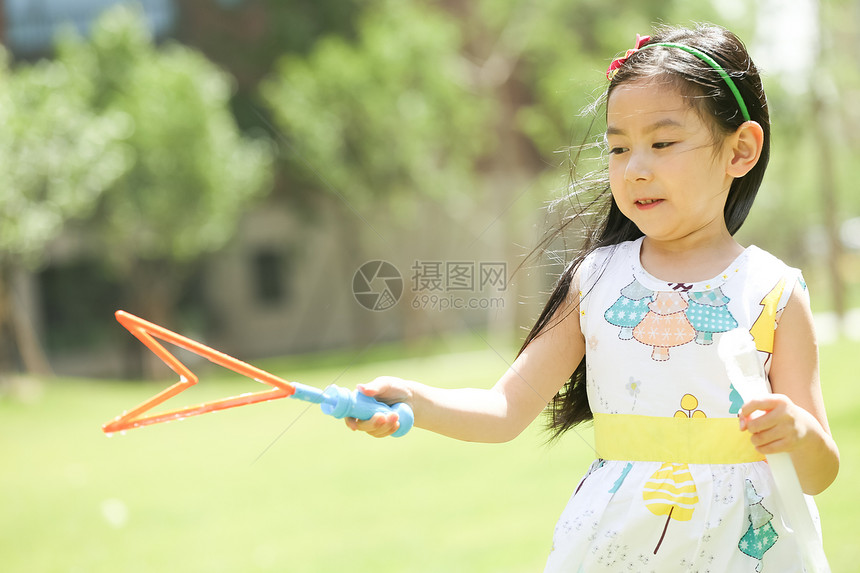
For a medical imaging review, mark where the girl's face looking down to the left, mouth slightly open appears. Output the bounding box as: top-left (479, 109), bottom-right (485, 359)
top-left (606, 80), bottom-right (733, 247)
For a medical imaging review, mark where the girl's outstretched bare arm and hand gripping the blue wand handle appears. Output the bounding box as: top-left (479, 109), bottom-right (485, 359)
top-left (347, 288), bottom-right (585, 442)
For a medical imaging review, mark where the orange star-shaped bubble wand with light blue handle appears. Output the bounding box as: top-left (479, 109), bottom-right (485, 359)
top-left (102, 310), bottom-right (414, 437)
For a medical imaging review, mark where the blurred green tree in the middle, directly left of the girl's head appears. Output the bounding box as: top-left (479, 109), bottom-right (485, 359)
top-left (262, 0), bottom-right (744, 340)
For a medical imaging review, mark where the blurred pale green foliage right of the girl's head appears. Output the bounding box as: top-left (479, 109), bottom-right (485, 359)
top-left (741, 0), bottom-right (860, 316)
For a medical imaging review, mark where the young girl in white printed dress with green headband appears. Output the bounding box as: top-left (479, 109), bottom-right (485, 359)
top-left (347, 27), bottom-right (839, 573)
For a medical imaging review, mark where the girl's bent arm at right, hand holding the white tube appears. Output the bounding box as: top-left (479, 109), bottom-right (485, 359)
top-left (740, 285), bottom-right (839, 495)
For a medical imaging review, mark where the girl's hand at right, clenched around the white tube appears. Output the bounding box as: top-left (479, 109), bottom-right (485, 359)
top-left (739, 394), bottom-right (818, 455)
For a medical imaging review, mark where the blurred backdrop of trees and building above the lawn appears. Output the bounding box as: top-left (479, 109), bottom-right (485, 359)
top-left (0, 0), bottom-right (860, 375)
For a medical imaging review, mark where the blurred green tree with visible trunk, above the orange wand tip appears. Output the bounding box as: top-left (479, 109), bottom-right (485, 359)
top-left (57, 6), bottom-right (272, 348)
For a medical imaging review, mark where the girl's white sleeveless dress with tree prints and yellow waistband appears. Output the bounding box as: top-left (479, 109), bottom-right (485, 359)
top-left (545, 239), bottom-right (818, 573)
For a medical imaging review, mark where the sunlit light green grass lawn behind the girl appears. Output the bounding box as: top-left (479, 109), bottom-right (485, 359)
top-left (0, 342), bottom-right (860, 573)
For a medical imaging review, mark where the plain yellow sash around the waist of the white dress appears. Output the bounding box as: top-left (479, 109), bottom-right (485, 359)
top-left (594, 413), bottom-right (765, 464)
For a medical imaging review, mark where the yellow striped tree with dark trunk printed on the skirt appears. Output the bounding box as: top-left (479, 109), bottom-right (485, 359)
top-left (642, 463), bottom-right (699, 555)
